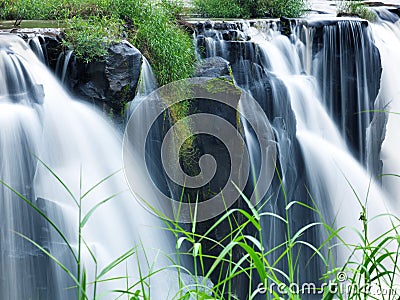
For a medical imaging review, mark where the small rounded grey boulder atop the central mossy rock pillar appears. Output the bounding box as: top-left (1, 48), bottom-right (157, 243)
top-left (194, 56), bottom-right (232, 79)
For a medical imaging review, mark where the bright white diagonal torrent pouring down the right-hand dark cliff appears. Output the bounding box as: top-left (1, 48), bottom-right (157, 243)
top-left (253, 23), bottom-right (394, 265)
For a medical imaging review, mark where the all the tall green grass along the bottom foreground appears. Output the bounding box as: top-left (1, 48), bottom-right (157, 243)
top-left (0, 161), bottom-right (400, 300)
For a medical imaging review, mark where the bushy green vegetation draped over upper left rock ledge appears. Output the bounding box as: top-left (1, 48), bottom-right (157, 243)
top-left (0, 0), bottom-right (194, 85)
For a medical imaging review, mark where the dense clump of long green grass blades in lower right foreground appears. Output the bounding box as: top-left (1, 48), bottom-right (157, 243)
top-left (145, 168), bottom-right (400, 300)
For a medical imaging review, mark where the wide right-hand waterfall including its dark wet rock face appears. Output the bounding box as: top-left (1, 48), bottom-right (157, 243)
top-left (195, 18), bottom-right (398, 288)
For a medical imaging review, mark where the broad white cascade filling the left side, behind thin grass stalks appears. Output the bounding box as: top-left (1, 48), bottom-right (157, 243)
top-left (0, 34), bottom-right (175, 299)
